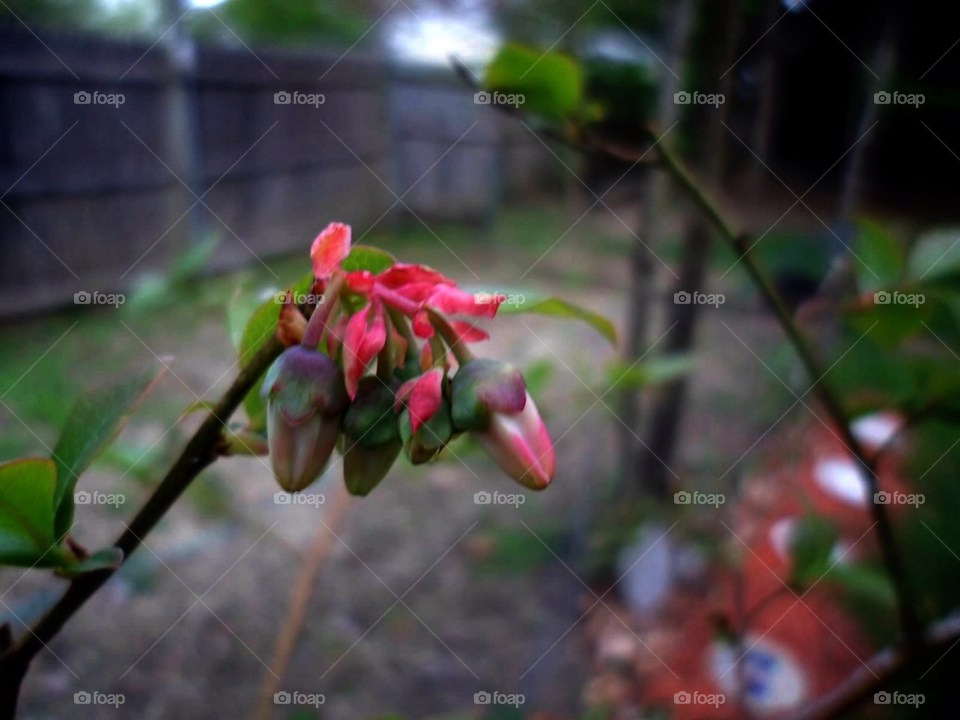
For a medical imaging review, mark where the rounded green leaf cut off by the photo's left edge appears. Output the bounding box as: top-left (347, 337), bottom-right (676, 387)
top-left (0, 458), bottom-right (61, 567)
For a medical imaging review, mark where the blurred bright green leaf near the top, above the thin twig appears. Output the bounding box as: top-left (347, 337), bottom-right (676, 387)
top-left (482, 43), bottom-right (583, 121)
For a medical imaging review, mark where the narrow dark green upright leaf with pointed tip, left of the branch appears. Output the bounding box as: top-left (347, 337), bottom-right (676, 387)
top-left (53, 362), bottom-right (166, 537)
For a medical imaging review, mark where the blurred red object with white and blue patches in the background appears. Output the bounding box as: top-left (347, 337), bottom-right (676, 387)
top-left (638, 413), bottom-right (908, 720)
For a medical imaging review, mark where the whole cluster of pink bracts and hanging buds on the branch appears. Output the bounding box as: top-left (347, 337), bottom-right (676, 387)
top-left (261, 223), bottom-right (555, 495)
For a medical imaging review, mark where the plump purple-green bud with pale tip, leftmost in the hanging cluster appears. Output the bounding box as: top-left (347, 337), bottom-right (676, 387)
top-left (261, 345), bottom-right (348, 492)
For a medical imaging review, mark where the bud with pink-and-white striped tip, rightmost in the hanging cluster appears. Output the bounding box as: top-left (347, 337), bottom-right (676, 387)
top-left (451, 359), bottom-right (556, 490)
